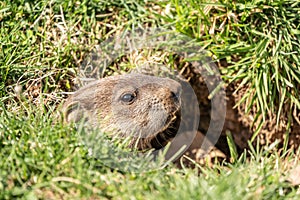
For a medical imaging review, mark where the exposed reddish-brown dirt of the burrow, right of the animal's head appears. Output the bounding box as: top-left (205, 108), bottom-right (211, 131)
top-left (176, 60), bottom-right (300, 156)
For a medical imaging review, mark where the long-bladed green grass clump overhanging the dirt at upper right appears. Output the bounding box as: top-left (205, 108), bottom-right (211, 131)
top-left (172, 0), bottom-right (300, 132)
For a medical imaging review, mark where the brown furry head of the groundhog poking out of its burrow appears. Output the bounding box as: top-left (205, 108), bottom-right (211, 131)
top-left (63, 74), bottom-right (181, 150)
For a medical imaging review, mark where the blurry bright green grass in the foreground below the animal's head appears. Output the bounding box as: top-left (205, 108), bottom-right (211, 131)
top-left (0, 108), bottom-right (299, 199)
